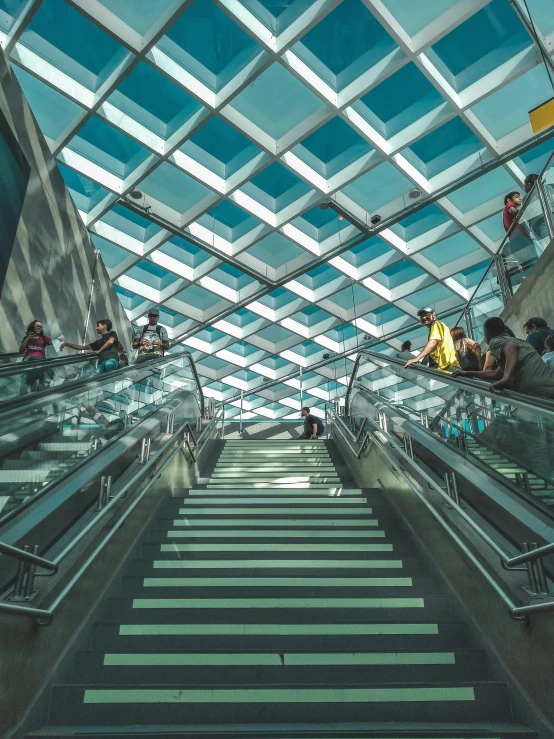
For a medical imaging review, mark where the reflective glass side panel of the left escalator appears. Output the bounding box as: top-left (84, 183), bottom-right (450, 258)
top-left (0, 353), bottom-right (202, 521)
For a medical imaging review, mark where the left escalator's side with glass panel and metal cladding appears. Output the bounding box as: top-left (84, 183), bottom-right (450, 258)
top-left (0, 352), bottom-right (204, 585)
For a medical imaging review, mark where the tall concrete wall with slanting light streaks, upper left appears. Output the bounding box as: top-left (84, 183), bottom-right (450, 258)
top-left (0, 50), bottom-right (131, 352)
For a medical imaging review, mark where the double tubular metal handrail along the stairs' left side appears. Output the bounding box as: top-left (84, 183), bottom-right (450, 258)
top-left (0, 413), bottom-right (218, 626)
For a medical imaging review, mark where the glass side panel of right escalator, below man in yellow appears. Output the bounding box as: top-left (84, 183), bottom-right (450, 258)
top-left (348, 352), bottom-right (554, 513)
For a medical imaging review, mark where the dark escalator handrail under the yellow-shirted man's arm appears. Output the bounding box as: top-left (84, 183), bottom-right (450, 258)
top-left (345, 349), bottom-right (554, 421)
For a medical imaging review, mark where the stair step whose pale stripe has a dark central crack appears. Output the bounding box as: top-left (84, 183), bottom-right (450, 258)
top-left (67, 645), bottom-right (487, 690)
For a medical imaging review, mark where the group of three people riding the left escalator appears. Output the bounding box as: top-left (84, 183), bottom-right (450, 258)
top-left (19, 308), bottom-right (169, 390)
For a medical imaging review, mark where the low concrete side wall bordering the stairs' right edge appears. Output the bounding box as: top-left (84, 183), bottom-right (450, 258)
top-left (333, 432), bottom-right (554, 739)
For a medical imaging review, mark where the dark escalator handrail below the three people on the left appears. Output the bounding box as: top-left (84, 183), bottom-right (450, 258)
top-left (0, 351), bottom-right (204, 419)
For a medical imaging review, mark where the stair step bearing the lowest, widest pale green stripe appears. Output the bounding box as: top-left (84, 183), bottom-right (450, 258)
top-left (50, 681), bottom-right (511, 726)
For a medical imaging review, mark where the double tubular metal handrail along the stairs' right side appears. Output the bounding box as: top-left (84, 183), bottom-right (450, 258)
top-left (330, 409), bottom-right (554, 622)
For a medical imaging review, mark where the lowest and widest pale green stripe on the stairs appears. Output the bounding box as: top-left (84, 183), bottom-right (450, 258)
top-left (83, 686), bottom-right (475, 705)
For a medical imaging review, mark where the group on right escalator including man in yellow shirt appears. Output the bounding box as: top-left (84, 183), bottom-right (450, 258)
top-left (397, 306), bottom-right (554, 398)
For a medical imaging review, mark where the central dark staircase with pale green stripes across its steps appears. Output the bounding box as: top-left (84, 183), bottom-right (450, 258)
top-left (28, 441), bottom-right (534, 739)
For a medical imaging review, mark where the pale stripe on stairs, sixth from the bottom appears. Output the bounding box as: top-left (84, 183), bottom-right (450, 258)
top-left (153, 558), bottom-right (402, 570)
